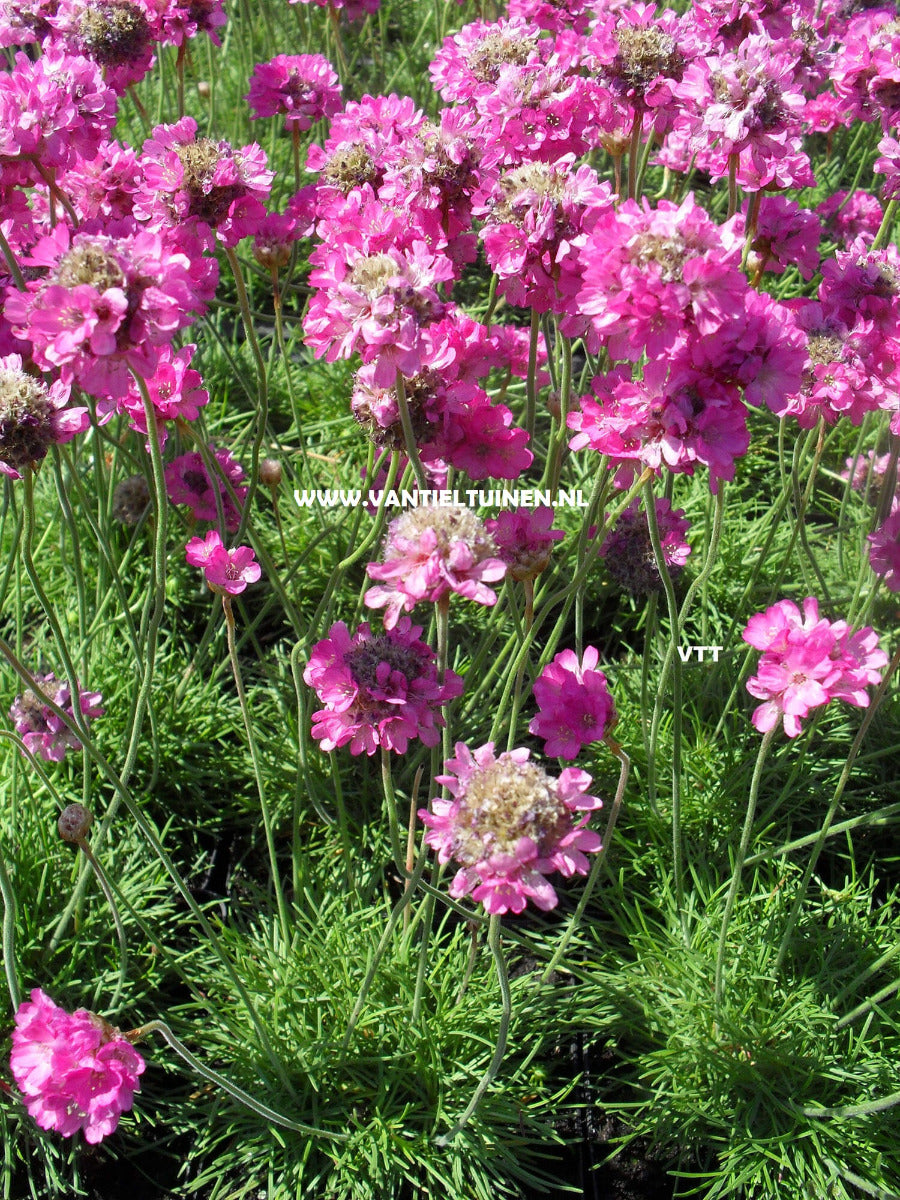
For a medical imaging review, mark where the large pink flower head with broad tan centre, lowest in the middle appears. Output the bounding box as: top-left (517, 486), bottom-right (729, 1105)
top-left (419, 742), bottom-right (602, 914)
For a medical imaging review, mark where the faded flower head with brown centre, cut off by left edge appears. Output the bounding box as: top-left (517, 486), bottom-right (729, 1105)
top-left (0, 354), bottom-right (90, 479)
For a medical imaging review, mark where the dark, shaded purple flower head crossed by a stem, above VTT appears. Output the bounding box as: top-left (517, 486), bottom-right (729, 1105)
top-left (600, 498), bottom-right (691, 595)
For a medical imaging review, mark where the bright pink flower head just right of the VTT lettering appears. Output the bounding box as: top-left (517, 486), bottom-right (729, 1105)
top-left (742, 596), bottom-right (888, 738)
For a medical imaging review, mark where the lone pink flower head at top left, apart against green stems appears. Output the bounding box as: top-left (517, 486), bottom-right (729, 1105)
top-left (245, 54), bottom-right (341, 131)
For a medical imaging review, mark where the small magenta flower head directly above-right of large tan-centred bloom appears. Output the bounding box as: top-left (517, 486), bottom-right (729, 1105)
top-left (528, 646), bottom-right (616, 758)
